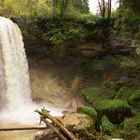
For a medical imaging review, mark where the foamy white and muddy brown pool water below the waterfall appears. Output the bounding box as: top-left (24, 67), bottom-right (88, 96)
top-left (0, 102), bottom-right (63, 140)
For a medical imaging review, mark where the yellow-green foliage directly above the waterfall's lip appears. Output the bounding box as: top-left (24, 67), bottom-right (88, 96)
top-left (0, 0), bottom-right (47, 17)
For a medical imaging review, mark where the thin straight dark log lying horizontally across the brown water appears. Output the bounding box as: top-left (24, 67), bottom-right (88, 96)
top-left (0, 127), bottom-right (48, 131)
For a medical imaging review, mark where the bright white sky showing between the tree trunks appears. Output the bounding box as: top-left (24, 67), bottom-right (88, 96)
top-left (89, 0), bottom-right (118, 14)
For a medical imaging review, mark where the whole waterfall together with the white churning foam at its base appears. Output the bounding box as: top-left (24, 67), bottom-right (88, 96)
top-left (0, 17), bottom-right (63, 123)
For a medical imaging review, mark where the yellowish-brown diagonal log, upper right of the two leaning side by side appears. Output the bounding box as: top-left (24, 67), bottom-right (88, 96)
top-left (35, 109), bottom-right (77, 140)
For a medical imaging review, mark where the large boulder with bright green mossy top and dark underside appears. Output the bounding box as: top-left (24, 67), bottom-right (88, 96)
top-left (96, 99), bottom-right (131, 123)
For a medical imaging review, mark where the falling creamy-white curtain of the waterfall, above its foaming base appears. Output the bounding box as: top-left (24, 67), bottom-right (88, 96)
top-left (0, 17), bottom-right (31, 109)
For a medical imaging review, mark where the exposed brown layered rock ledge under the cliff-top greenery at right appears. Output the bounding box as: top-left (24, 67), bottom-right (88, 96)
top-left (79, 36), bottom-right (135, 58)
